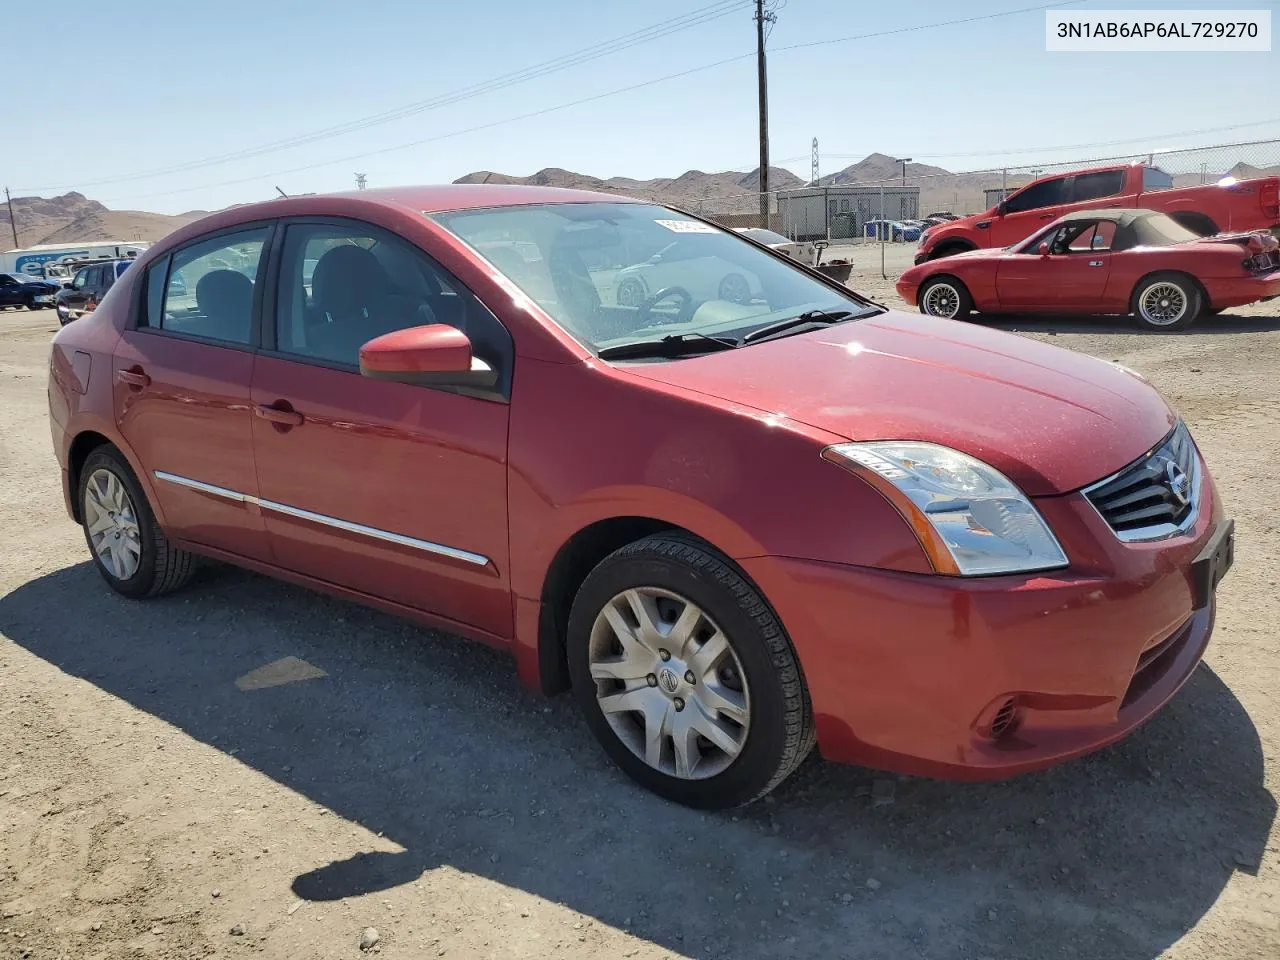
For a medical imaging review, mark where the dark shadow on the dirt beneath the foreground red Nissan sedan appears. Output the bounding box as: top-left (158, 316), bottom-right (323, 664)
top-left (0, 563), bottom-right (1276, 960)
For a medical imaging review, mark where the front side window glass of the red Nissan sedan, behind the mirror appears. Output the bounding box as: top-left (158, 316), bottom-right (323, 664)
top-left (275, 223), bottom-right (512, 389)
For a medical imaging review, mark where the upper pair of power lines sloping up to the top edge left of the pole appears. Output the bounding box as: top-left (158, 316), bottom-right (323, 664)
top-left (17, 0), bottom-right (751, 192)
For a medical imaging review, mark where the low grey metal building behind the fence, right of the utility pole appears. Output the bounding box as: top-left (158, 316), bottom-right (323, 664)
top-left (777, 184), bottom-right (920, 241)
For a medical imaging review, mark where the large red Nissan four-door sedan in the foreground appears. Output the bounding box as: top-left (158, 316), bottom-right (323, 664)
top-left (49, 186), bottom-right (1233, 808)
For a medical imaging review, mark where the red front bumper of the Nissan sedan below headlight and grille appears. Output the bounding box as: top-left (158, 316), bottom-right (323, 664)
top-left (742, 471), bottom-right (1222, 780)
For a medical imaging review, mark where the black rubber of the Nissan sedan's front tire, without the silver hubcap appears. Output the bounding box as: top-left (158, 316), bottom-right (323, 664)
top-left (567, 532), bottom-right (814, 809)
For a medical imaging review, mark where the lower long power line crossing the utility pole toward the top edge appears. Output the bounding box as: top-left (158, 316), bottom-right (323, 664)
top-left (104, 0), bottom-right (1088, 202)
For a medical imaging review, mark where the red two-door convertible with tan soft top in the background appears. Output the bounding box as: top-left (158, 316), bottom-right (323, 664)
top-left (897, 210), bottom-right (1280, 330)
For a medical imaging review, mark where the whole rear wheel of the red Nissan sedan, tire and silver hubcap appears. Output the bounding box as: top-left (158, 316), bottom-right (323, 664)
top-left (77, 447), bottom-right (196, 599)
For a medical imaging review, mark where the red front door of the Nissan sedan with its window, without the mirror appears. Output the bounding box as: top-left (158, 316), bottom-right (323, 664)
top-left (251, 220), bottom-right (512, 637)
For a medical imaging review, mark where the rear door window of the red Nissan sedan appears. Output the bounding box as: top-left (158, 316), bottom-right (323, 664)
top-left (143, 227), bottom-right (270, 344)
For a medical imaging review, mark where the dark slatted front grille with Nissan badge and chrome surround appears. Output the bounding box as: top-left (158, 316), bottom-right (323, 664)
top-left (1084, 422), bottom-right (1201, 540)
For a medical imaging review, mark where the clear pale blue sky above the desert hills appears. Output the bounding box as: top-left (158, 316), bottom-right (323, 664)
top-left (0, 0), bottom-right (1280, 212)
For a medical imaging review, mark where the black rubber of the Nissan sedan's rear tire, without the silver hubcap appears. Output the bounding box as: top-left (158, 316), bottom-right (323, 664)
top-left (76, 445), bottom-right (196, 599)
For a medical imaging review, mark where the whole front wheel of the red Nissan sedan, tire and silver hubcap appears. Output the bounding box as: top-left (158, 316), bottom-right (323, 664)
top-left (566, 532), bottom-right (814, 810)
